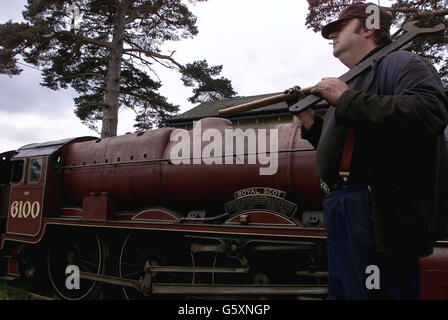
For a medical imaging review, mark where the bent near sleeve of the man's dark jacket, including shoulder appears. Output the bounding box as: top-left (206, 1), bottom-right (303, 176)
top-left (335, 56), bottom-right (448, 136)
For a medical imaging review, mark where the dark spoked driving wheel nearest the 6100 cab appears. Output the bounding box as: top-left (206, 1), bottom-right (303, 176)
top-left (47, 231), bottom-right (105, 300)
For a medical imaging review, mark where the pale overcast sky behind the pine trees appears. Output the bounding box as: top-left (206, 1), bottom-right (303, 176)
top-left (0, 0), bottom-right (378, 152)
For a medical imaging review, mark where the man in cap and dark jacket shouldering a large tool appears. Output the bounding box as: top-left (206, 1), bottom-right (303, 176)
top-left (290, 3), bottom-right (448, 299)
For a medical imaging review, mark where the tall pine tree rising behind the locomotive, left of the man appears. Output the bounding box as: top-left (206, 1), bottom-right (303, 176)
top-left (0, 0), bottom-right (236, 137)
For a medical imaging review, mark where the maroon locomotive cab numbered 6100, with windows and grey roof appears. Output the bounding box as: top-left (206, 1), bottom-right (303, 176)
top-left (1, 137), bottom-right (96, 237)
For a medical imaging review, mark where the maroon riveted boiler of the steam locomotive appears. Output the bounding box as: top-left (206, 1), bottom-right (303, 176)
top-left (63, 118), bottom-right (320, 217)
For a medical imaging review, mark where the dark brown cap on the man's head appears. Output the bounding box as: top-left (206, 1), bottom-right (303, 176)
top-left (321, 2), bottom-right (392, 39)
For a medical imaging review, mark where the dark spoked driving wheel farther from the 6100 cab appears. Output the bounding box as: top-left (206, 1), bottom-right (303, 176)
top-left (119, 232), bottom-right (194, 300)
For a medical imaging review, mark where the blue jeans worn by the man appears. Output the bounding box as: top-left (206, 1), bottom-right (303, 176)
top-left (323, 185), bottom-right (420, 300)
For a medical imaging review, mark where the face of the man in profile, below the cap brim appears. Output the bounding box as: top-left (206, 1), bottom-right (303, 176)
top-left (329, 18), bottom-right (363, 59)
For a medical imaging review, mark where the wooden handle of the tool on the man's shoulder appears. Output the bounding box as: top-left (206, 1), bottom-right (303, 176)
top-left (219, 87), bottom-right (314, 117)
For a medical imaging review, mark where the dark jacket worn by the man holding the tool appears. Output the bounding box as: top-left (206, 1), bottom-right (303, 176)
top-left (305, 51), bottom-right (448, 257)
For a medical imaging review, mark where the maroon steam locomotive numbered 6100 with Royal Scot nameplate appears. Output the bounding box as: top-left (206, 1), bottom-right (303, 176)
top-left (0, 118), bottom-right (448, 300)
